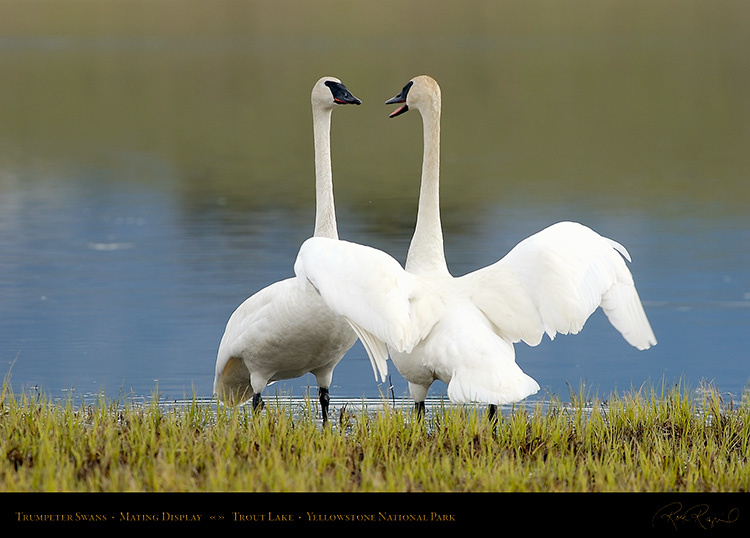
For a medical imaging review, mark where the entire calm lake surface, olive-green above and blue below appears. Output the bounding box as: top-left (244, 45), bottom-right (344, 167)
top-left (0, 0), bottom-right (750, 400)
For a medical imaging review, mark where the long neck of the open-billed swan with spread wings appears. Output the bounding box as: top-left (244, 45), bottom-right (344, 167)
top-left (406, 100), bottom-right (449, 274)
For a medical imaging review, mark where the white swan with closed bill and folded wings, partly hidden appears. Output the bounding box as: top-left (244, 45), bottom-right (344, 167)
top-left (214, 77), bottom-right (361, 421)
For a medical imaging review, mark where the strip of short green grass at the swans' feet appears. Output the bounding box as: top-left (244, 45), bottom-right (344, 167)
top-left (0, 376), bottom-right (750, 492)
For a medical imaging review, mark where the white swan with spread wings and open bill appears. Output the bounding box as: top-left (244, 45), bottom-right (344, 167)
top-left (295, 76), bottom-right (656, 416)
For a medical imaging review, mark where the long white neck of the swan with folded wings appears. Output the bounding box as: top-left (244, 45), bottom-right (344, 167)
top-left (313, 107), bottom-right (339, 239)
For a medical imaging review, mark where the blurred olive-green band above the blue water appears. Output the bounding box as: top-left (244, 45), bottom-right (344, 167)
top-left (0, 0), bottom-right (750, 219)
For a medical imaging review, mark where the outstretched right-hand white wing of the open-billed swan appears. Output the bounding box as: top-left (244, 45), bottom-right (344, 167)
top-left (460, 222), bottom-right (656, 349)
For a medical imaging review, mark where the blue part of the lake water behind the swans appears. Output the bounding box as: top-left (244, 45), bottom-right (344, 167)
top-left (0, 165), bottom-right (750, 400)
